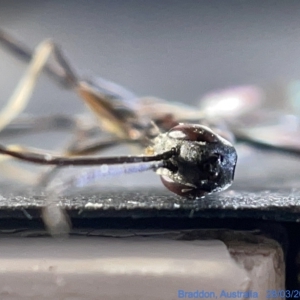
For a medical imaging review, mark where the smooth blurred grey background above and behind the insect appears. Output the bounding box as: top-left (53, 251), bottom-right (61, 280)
top-left (0, 0), bottom-right (300, 191)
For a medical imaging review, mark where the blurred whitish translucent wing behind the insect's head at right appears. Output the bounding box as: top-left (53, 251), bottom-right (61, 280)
top-left (209, 83), bottom-right (300, 155)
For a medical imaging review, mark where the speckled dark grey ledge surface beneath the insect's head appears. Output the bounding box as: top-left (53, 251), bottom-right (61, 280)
top-left (0, 185), bottom-right (300, 222)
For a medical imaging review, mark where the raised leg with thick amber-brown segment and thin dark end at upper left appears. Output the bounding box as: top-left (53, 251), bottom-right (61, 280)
top-left (0, 31), bottom-right (150, 139)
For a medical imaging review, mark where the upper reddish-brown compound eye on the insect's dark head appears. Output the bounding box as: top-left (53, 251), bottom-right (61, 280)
top-left (168, 124), bottom-right (218, 143)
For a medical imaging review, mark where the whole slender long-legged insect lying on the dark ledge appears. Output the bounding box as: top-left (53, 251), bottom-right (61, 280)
top-left (0, 31), bottom-right (299, 234)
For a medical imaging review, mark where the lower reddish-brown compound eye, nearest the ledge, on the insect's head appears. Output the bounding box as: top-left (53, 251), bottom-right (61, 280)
top-left (160, 176), bottom-right (208, 198)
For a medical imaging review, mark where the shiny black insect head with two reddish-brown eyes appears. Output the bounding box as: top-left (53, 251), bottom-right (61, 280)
top-left (159, 124), bottom-right (237, 198)
